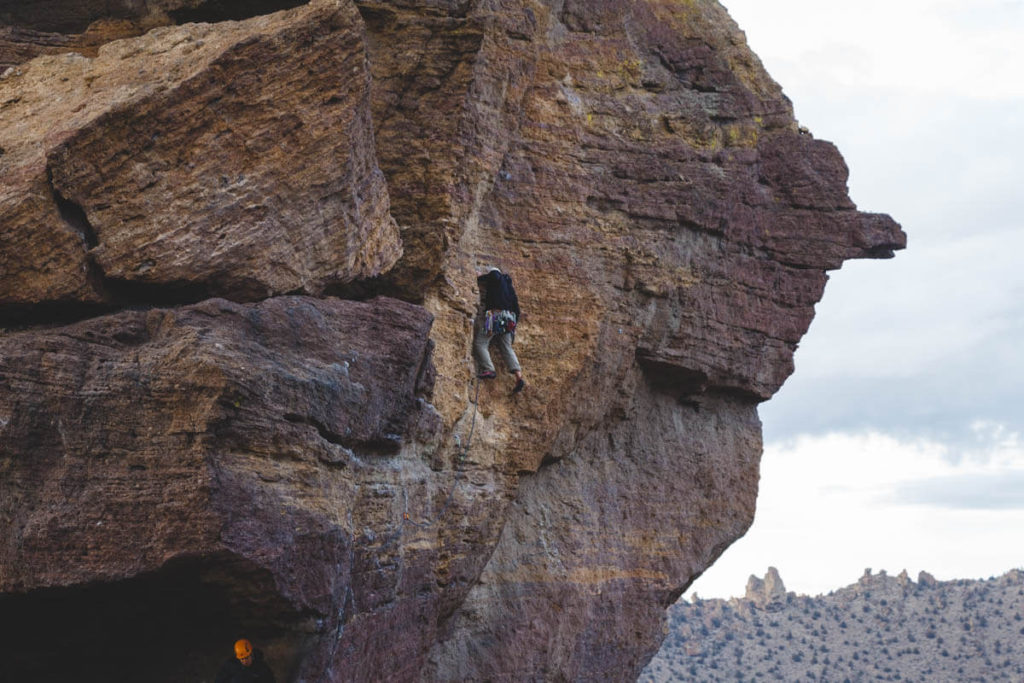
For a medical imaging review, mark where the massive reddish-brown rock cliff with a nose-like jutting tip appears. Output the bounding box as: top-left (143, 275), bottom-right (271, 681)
top-left (0, 0), bottom-right (905, 681)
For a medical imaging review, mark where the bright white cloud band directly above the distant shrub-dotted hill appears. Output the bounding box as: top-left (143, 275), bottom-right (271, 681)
top-left (691, 432), bottom-right (1024, 597)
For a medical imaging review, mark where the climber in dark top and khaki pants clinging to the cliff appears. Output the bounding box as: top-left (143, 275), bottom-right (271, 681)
top-left (473, 267), bottom-right (526, 393)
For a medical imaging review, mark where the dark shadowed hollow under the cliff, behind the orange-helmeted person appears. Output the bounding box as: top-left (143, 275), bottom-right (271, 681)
top-left (0, 555), bottom-right (311, 683)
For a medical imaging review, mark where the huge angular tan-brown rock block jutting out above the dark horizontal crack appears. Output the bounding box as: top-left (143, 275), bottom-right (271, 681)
top-left (0, 0), bottom-right (400, 305)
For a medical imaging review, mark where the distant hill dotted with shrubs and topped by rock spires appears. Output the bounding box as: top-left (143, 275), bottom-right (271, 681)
top-left (638, 567), bottom-right (1024, 683)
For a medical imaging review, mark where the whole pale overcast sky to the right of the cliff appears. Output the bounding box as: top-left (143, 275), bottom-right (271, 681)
top-left (690, 0), bottom-right (1024, 598)
